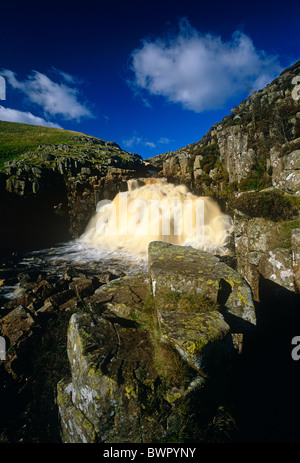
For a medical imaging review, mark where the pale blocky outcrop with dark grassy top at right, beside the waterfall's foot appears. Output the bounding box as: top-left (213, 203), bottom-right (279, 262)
top-left (232, 191), bottom-right (300, 301)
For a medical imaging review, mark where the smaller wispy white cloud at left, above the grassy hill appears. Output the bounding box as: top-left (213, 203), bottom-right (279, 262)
top-left (1, 69), bottom-right (92, 120)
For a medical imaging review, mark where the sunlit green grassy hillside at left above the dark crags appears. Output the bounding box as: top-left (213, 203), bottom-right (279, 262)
top-left (0, 121), bottom-right (93, 167)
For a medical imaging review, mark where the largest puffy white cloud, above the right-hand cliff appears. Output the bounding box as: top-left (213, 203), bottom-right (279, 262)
top-left (131, 20), bottom-right (282, 112)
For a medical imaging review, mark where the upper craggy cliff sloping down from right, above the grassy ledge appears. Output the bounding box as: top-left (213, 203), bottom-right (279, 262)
top-left (148, 61), bottom-right (300, 197)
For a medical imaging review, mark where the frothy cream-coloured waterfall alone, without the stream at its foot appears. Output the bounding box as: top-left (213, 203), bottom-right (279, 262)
top-left (80, 178), bottom-right (232, 256)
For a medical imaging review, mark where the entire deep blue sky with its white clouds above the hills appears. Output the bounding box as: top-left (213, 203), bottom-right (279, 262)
top-left (0, 0), bottom-right (300, 158)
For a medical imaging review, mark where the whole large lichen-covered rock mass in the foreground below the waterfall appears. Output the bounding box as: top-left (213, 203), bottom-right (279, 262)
top-left (58, 242), bottom-right (255, 443)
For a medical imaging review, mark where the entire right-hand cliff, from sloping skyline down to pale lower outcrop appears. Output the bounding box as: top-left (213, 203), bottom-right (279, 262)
top-left (148, 61), bottom-right (300, 301)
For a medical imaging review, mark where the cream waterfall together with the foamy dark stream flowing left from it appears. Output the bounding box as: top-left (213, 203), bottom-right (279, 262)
top-left (0, 178), bottom-right (232, 308)
